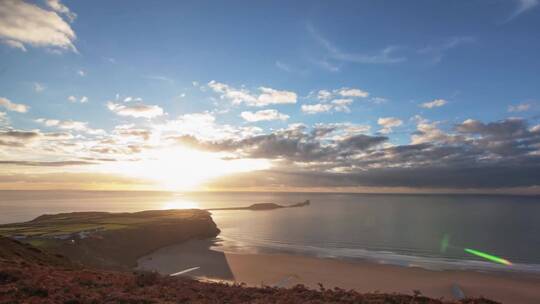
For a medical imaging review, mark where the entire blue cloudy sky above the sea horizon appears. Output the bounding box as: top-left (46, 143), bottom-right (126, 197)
top-left (0, 0), bottom-right (540, 194)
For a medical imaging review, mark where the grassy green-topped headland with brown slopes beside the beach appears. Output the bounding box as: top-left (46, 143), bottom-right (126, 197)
top-left (0, 210), bottom-right (219, 268)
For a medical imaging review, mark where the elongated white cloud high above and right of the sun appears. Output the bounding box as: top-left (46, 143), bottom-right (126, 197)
top-left (208, 80), bottom-right (297, 107)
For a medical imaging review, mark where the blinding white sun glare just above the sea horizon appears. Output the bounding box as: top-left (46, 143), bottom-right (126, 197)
top-left (97, 147), bottom-right (270, 190)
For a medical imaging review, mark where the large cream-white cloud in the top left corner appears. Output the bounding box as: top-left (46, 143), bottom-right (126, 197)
top-left (0, 0), bottom-right (77, 52)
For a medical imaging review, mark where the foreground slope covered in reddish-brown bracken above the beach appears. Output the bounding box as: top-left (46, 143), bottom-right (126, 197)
top-left (0, 237), bottom-right (496, 304)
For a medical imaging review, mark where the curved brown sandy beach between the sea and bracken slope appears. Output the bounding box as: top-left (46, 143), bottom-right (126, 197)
top-left (138, 241), bottom-right (540, 304)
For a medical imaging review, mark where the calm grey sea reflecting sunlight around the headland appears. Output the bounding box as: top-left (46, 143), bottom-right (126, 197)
top-left (0, 191), bottom-right (540, 273)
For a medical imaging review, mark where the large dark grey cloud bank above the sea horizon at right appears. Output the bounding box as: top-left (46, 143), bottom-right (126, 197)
top-left (202, 119), bottom-right (540, 189)
